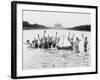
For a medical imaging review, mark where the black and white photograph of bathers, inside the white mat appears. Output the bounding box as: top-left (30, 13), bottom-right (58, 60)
top-left (23, 10), bottom-right (91, 70)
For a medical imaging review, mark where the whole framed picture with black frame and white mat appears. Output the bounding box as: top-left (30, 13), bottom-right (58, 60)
top-left (12, 2), bottom-right (97, 78)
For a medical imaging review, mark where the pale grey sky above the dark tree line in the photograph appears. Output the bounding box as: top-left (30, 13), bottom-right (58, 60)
top-left (23, 10), bottom-right (91, 27)
